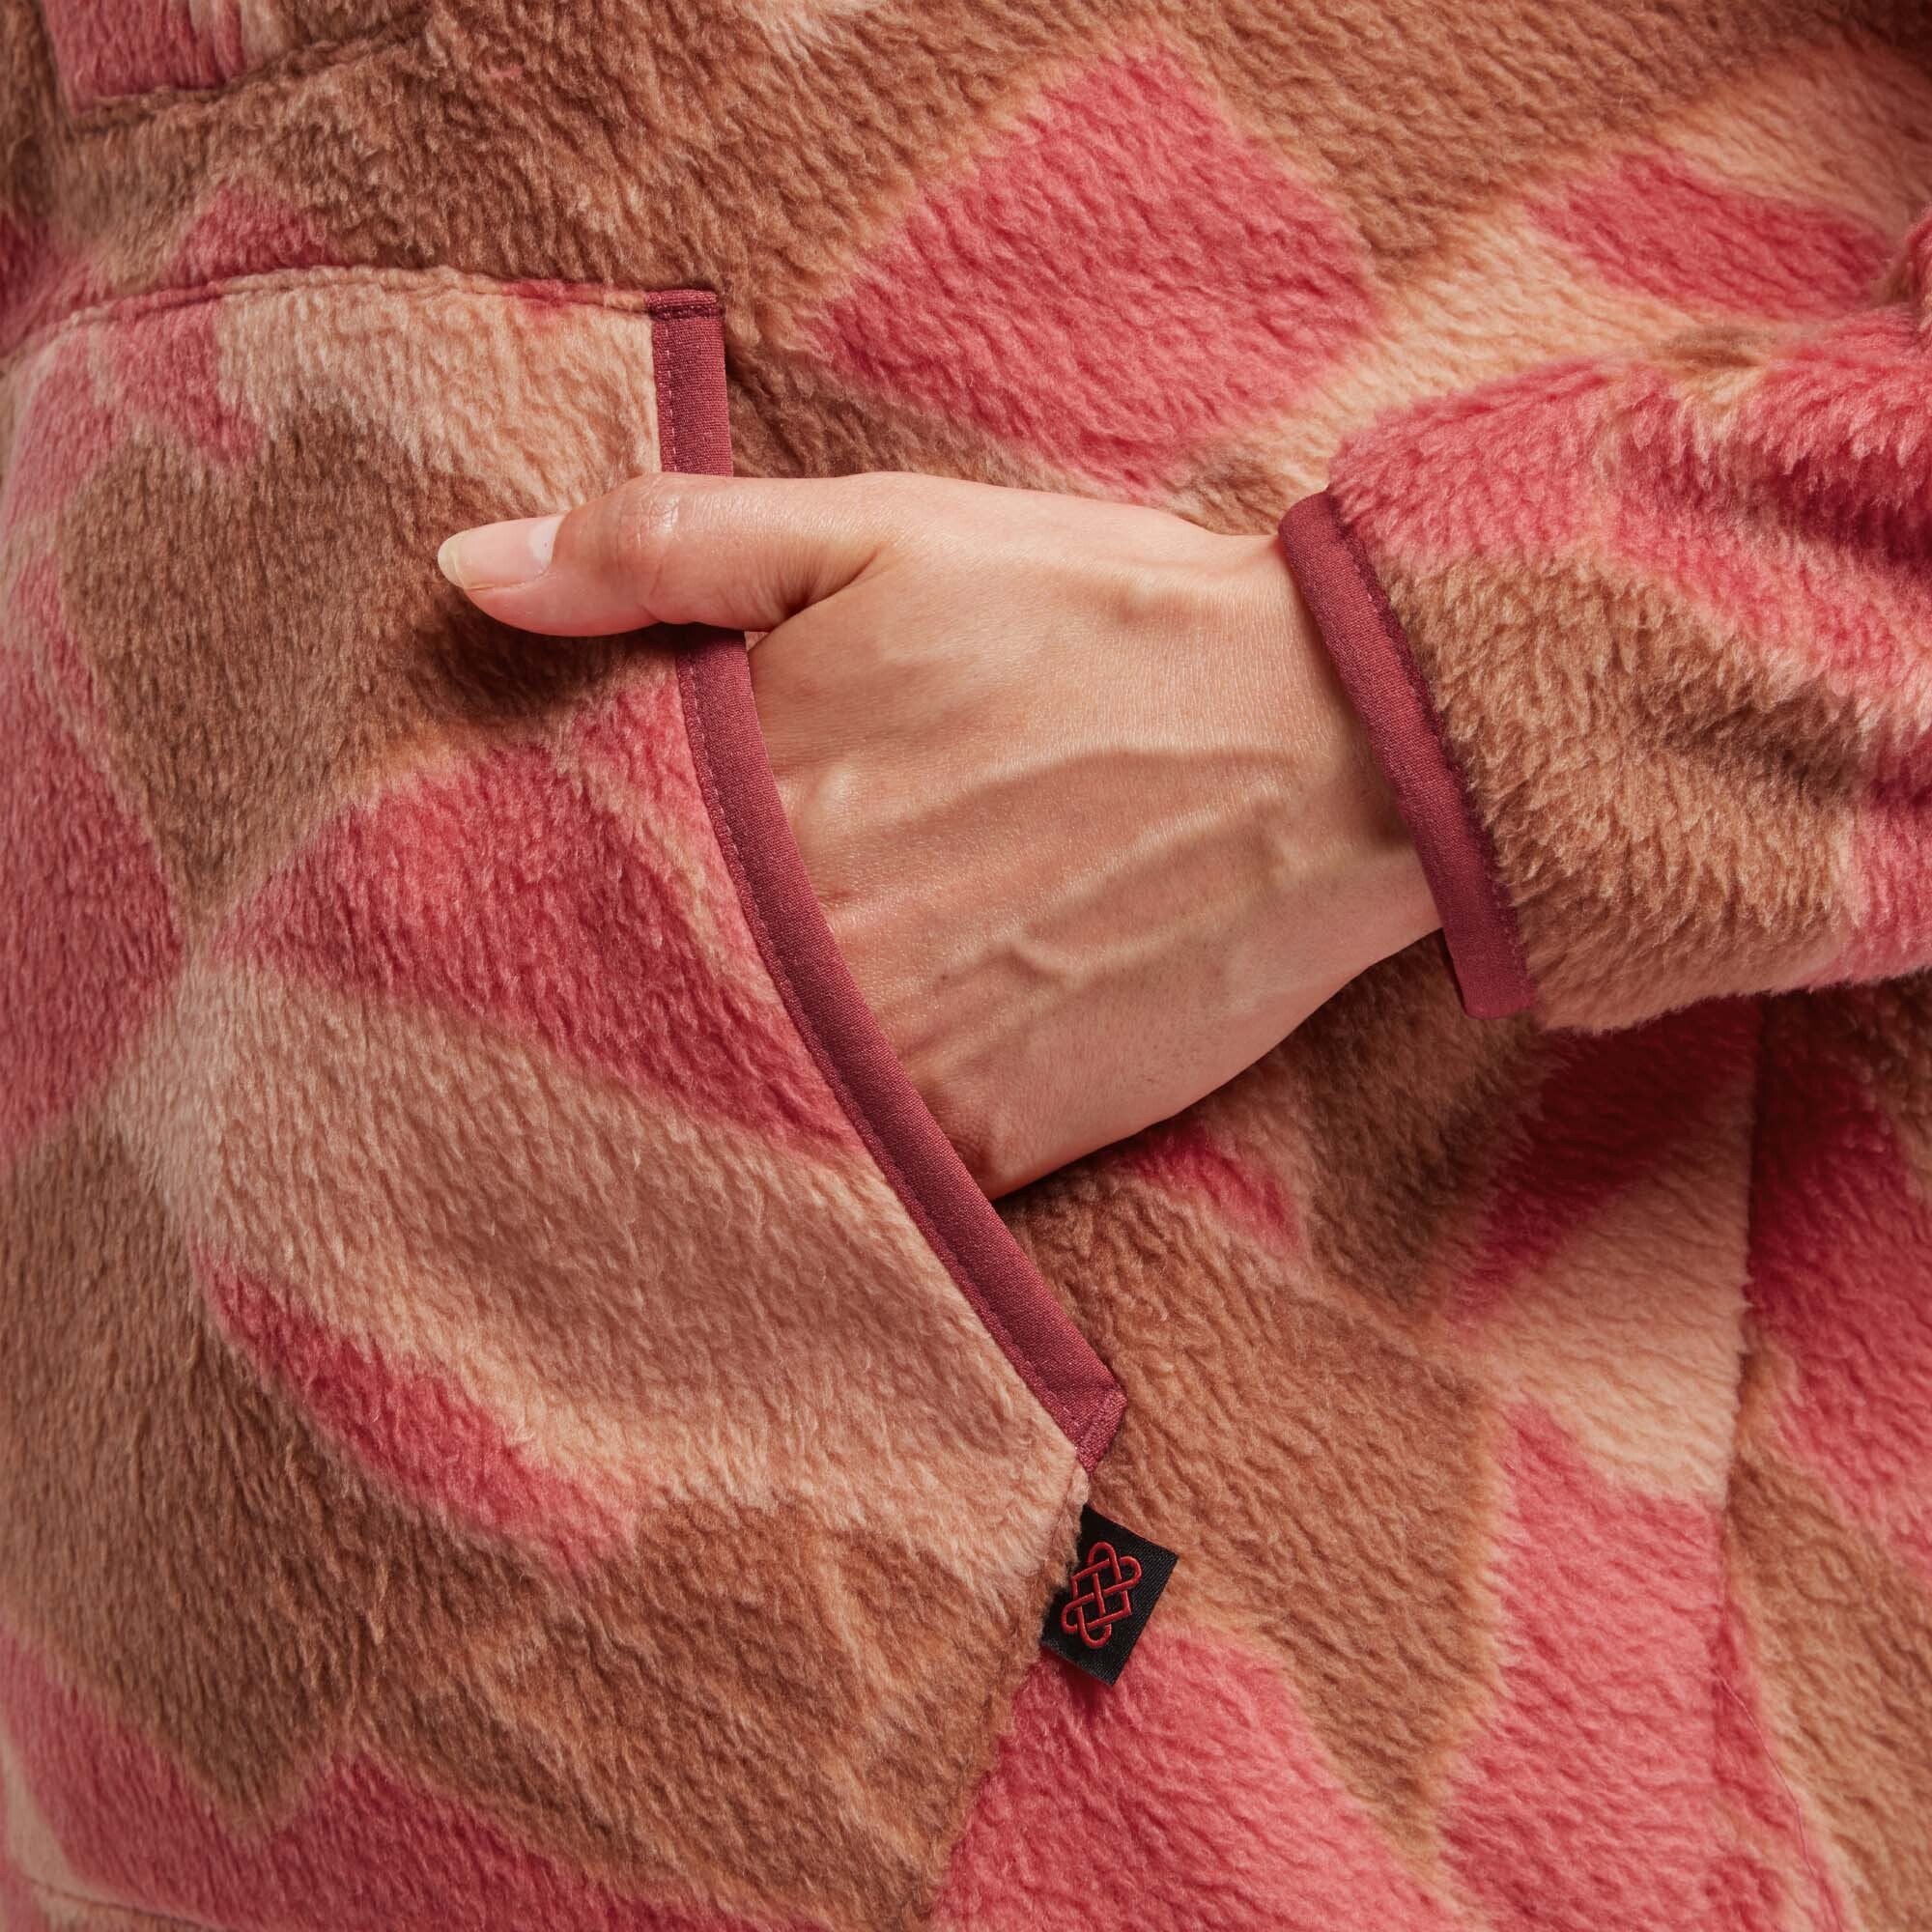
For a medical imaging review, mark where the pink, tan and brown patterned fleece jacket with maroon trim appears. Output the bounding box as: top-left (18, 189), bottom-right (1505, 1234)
top-left (0, 0), bottom-right (1932, 1932)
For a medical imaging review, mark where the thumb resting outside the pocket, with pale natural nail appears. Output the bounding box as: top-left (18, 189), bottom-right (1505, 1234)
top-left (437, 475), bottom-right (891, 638)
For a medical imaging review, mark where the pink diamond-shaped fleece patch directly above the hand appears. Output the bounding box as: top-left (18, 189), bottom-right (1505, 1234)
top-left (811, 50), bottom-right (1376, 493)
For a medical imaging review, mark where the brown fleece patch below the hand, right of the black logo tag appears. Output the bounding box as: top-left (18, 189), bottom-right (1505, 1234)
top-left (1024, 1128), bottom-right (1493, 1870)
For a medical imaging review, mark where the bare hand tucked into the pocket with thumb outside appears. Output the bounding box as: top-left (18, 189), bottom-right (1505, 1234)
top-left (440, 475), bottom-right (1435, 1194)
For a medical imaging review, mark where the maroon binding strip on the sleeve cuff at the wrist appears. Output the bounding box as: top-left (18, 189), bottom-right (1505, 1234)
top-left (1281, 491), bottom-right (1536, 1020)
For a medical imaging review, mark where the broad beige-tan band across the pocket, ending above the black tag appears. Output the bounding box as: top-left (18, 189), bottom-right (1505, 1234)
top-left (116, 968), bottom-right (1072, 1590)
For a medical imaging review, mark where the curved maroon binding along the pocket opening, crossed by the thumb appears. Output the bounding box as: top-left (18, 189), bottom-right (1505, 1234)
top-left (653, 313), bottom-right (1126, 1468)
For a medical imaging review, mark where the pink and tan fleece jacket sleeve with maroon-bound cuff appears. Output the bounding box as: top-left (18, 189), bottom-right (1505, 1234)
top-left (1281, 216), bottom-right (1932, 1026)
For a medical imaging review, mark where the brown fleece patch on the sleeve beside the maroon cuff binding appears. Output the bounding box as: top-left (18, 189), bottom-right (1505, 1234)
top-left (1389, 564), bottom-right (1864, 1026)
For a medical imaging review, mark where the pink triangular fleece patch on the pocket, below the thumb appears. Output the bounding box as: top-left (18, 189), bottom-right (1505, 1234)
top-left (220, 734), bottom-right (852, 1153)
